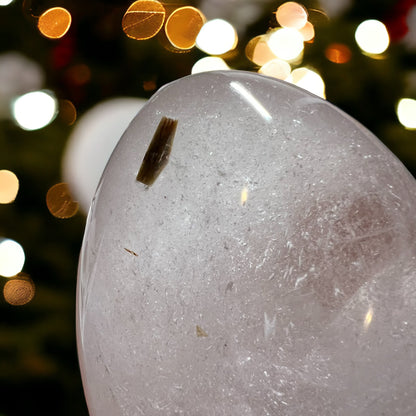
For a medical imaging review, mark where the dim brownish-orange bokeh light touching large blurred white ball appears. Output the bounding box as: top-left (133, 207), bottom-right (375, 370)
top-left (46, 182), bottom-right (79, 219)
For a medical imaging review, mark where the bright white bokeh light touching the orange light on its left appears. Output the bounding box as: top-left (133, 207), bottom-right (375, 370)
top-left (196, 19), bottom-right (238, 55)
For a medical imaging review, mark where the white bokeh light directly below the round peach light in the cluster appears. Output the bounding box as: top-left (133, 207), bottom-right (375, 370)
top-left (267, 28), bottom-right (304, 62)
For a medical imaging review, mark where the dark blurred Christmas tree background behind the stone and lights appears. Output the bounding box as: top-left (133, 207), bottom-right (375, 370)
top-left (0, 0), bottom-right (416, 416)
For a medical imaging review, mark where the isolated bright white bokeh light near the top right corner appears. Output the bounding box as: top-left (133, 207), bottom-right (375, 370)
top-left (355, 19), bottom-right (390, 55)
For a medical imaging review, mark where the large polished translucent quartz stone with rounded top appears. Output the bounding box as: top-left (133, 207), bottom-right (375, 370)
top-left (77, 71), bottom-right (416, 416)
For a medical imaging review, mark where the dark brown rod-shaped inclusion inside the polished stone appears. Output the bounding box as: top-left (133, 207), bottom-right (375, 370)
top-left (136, 117), bottom-right (178, 186)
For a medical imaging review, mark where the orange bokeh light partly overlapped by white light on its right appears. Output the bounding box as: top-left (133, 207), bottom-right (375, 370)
top-left (165, 6), bottom-right (205, 50)
